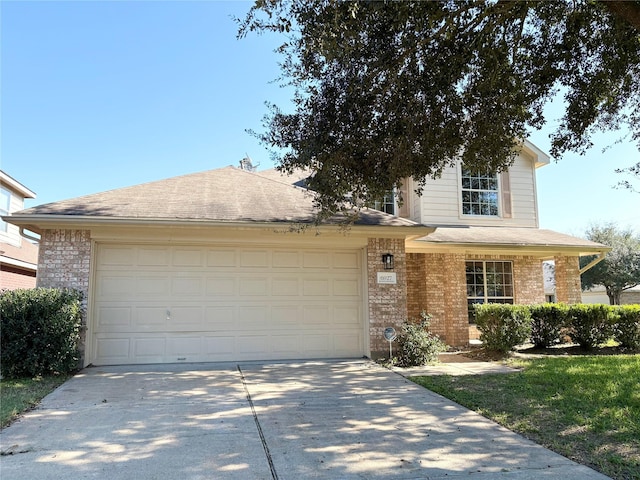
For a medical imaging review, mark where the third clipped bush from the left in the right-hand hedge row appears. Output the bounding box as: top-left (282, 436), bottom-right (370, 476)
top-left (569, 303), bottom-right (617, 350)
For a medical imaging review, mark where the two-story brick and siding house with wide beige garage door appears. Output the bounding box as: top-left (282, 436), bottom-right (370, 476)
top-left (3, 143), bottom-right (608, 365)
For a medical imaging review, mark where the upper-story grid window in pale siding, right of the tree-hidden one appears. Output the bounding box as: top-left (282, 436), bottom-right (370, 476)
top-left (462, 165), bottom-right (499, 217)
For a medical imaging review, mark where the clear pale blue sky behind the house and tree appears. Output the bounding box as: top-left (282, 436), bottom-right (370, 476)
top-left (0, 0), bottom-right (640, 237)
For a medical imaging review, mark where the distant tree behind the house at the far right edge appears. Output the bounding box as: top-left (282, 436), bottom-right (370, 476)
top-left (581, 224), bottom-right (640, 305)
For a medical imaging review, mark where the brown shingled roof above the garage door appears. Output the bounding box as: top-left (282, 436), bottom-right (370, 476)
top-left (8, 167), bottom-right (419, 231)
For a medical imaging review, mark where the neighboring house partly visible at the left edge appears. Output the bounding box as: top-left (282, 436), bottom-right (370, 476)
top-left (0, 171), bottom-right (38, 290)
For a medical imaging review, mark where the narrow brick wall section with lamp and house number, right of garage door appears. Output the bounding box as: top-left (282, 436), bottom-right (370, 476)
top-left (367, 238), bottom-right (407, 358)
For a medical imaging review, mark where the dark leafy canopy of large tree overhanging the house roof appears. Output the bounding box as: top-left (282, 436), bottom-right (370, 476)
top-left (238, 0), bottom-right (640, 218)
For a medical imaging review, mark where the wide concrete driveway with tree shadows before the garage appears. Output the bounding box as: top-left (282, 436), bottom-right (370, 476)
top-left (0, 360), bottom-right (607, 480)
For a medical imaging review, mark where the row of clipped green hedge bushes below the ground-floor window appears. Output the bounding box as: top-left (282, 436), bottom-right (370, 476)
top-left (474, 303), bottom-right (640, 352)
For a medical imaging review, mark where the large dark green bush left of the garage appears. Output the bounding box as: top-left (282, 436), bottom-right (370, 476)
top-left (0, 288), bottom-right (82, 378)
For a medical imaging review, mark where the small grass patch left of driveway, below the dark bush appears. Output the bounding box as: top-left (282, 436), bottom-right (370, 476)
top-left (0, 375), bottom-right (69, 428)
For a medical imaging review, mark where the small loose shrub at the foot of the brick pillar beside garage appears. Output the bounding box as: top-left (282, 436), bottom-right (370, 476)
top-left (394, 312), bottom-right (447, 367)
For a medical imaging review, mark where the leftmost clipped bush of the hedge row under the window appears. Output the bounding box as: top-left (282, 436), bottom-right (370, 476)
top-left (474, 303), bottom-right (531, 353)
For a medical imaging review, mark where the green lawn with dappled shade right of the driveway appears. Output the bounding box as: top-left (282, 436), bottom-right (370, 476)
top-left (412, 355), bottom-right (640, 480)
